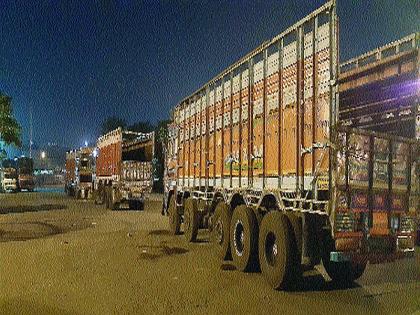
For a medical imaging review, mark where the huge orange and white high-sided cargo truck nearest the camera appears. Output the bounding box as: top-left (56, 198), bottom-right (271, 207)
top-left (163, 1), bottom-right (419, 289)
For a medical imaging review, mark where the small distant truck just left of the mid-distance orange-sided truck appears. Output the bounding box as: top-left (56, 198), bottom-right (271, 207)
top-left (64, 147), bottom-right (96, 199)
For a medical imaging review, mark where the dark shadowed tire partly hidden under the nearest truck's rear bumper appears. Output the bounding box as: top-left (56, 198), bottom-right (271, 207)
top-left (322, 230), bottom-right (367, 285)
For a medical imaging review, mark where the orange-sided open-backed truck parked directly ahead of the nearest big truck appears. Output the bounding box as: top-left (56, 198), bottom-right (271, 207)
top-left (94, 127), bottom-right (155, 210)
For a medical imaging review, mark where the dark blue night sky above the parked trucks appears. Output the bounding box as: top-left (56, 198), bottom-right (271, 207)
top-left (0, 0), bottom-right (420, 146)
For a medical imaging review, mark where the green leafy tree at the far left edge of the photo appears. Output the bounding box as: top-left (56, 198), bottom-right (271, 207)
top-left (0, 92), bottom-right (22, 147)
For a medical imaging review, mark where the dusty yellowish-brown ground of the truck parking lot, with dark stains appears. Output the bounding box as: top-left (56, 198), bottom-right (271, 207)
top-left (0, 193), bottom-right (420, 314)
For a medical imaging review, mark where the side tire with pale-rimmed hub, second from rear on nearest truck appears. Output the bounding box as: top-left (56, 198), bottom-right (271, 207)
top-left (230, 205), bottom-right (258, 271)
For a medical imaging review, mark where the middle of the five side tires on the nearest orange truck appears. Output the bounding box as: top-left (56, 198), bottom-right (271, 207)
top-left (210, 201), bottom-right (232, 260)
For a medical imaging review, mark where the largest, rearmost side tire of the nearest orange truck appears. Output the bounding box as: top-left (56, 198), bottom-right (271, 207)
top-left (258, 211), bottom-right (296, 290)
